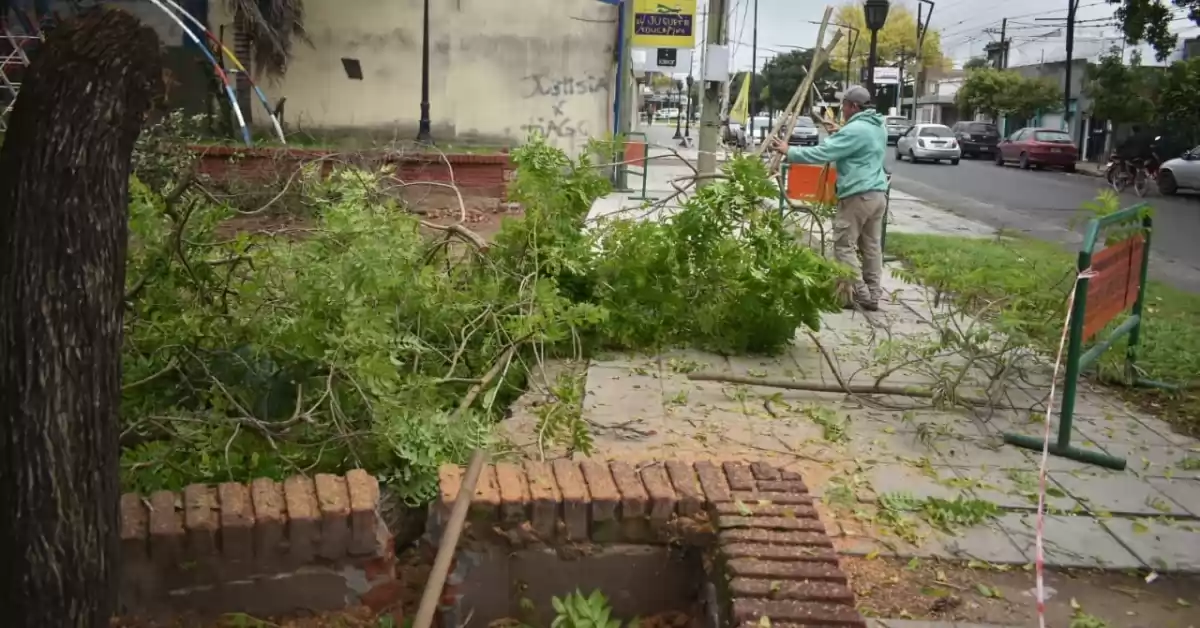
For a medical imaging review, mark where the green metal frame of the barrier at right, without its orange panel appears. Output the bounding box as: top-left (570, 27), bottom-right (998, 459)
top-left (1004, 203), bottom-right (1174, 471)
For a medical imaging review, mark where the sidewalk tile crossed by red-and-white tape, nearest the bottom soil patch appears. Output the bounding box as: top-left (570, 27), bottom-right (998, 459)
top-left (1000, 514), bottom-right (1142, 569)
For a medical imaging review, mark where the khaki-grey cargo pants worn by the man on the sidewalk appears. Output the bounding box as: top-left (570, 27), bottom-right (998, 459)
top-left (833, 191), bottom-right (888, 303)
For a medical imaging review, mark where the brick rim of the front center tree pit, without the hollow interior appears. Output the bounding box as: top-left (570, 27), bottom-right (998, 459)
top-left (428, 460), bottom-right (866, 628)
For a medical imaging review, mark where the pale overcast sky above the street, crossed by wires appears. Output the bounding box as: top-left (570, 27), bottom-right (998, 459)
top-left (694, 0), bottom-right (1200, 73)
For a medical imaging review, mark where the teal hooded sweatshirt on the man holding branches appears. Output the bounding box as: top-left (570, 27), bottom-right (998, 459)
top-left (787, 109), bottom-right (888, 198)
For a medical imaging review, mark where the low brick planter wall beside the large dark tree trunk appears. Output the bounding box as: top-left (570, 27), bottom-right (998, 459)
top-left (120, 469), bottom-right (400, 616)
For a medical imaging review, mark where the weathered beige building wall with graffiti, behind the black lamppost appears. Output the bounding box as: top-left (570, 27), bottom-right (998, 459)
top-left (210, 0), bottom-right (617, 154)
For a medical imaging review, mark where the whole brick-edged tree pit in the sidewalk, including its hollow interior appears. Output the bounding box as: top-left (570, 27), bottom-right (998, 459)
top-left (428, 459), bottom-right (866, 628)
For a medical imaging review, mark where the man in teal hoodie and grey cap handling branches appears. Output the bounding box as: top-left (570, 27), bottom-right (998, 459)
top-left (773, 85), bottom-right (888, 311)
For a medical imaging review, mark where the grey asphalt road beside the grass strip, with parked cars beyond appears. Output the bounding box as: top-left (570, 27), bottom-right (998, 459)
top-left (887, 157), bottom-right (1200, 293)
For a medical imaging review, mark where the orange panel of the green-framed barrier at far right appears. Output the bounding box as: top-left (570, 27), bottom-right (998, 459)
top-left (1084, 234), bottom-right (1146, 340)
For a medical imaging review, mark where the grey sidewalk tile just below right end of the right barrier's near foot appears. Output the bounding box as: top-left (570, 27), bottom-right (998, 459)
top-left (1054, 471), bottom-right (1188, 516)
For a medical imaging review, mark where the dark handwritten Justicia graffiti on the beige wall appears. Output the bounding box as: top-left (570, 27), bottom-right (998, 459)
top-left (521, 74), bottom-right (610, 155)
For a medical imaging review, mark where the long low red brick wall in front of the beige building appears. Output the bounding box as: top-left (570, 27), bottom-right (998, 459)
top-left (193, 145), bottom-right (514, 201)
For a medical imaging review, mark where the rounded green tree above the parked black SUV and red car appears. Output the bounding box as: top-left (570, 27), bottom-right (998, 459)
top-left (955, 67), bottom-right (1062, 120)
